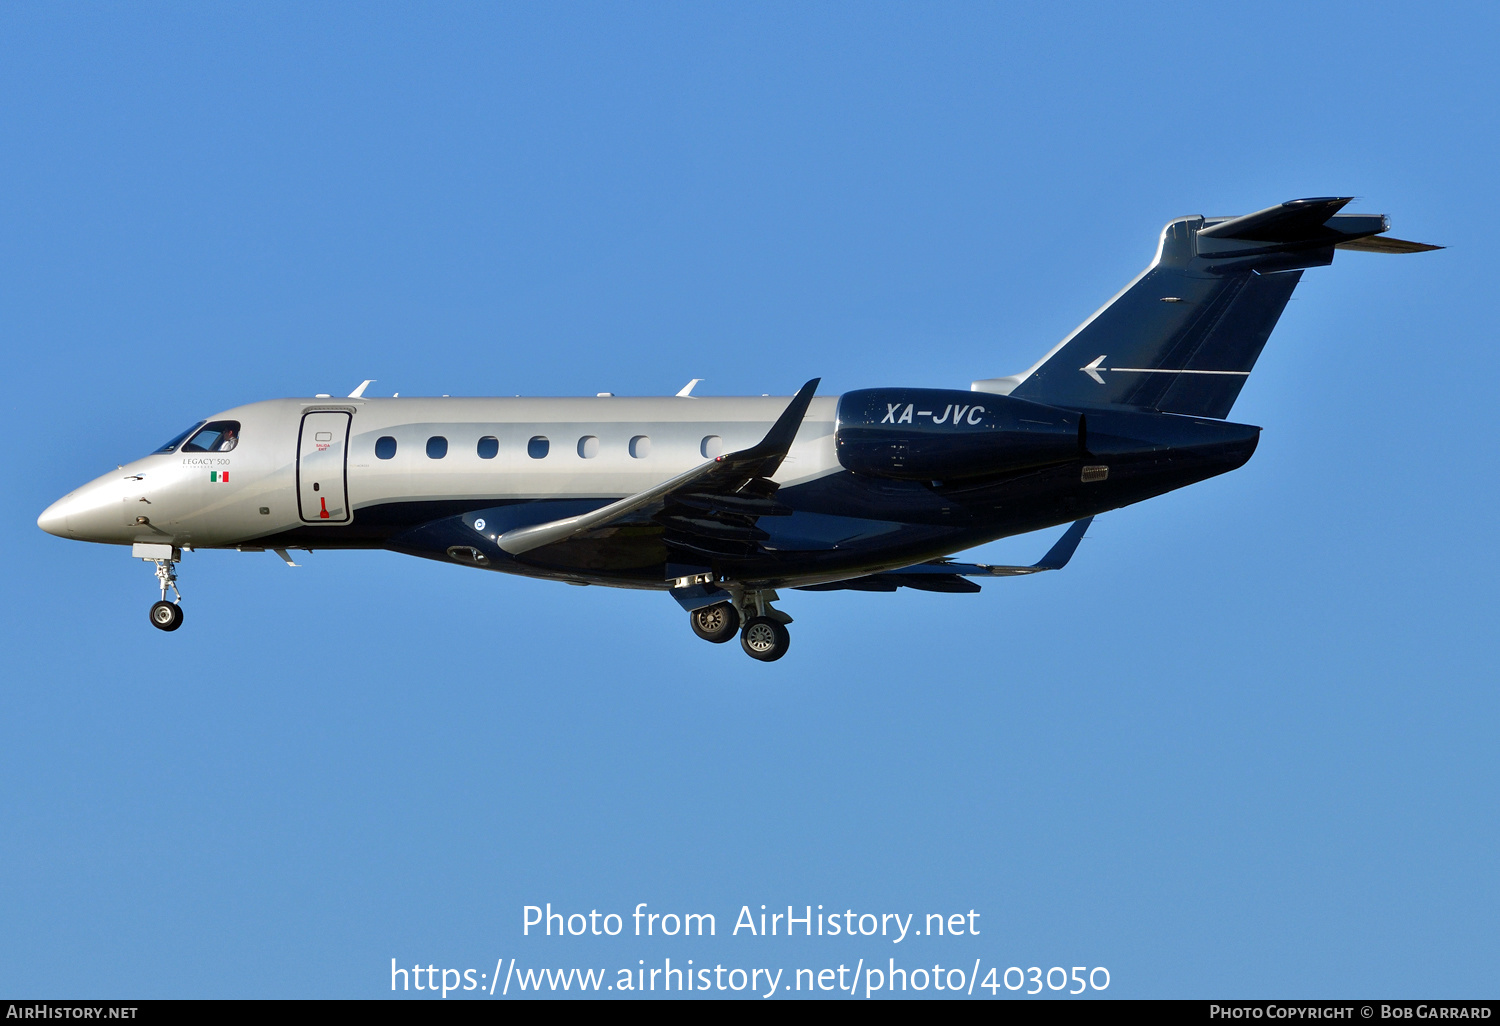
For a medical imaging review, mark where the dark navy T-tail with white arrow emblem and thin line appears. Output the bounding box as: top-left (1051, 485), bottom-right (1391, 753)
top-left (972, 197), bottom-right (1442, 419)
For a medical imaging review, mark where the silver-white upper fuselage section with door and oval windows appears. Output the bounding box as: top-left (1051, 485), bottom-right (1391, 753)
top-left (38, 396), bottom-right (840, 548)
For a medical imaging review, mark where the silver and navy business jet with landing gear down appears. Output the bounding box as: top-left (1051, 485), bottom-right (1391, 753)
top-left (38, 197), bottom-right (1439, 662)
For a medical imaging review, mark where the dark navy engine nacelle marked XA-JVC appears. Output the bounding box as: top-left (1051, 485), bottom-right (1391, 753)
top-left (834, 389), bottom-right (1083, 482)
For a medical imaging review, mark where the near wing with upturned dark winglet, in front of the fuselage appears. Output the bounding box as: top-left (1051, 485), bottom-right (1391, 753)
top-left (497, 378), bottom-right (821, 563)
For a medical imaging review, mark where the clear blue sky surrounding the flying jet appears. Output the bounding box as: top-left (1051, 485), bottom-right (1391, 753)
top-left (0, 5), bottom-right (1500, 998)
